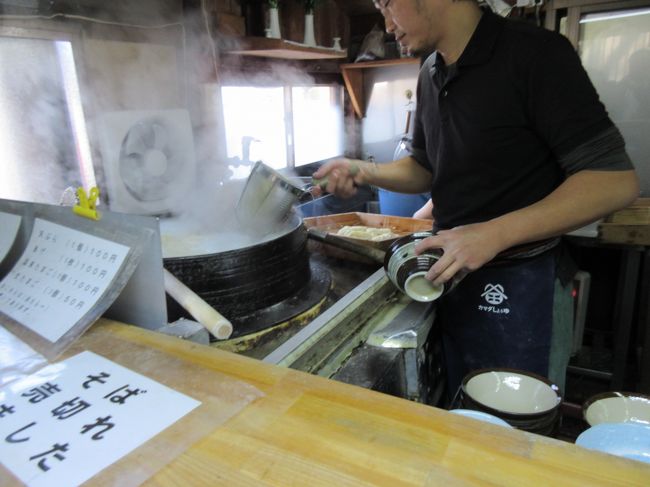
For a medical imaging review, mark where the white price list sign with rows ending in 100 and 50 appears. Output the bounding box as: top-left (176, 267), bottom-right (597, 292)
top-left (0, 218), bottom-right (129, 342)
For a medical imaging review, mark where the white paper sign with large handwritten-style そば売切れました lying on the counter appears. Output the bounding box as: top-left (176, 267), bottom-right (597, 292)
top-left (0, 352), bottom-right (201, 487)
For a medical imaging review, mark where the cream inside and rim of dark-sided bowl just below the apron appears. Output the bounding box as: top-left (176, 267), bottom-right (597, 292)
top-left (463, 369), bottom-right (562, 415)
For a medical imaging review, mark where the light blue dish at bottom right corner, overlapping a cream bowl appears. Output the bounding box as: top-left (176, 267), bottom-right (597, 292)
top-left (576, 423), bottom-right (650, 463)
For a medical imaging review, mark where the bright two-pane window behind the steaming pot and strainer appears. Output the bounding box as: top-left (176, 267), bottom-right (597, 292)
top-left (221, 85), bottom-right (343, 177)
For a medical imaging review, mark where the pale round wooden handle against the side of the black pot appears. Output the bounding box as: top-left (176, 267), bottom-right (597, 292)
top-left (163, 268), bottom-right (232, 340)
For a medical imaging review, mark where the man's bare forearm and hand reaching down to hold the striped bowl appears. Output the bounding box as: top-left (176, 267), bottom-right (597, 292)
top-left (417, 170), bottom-right (639, 284)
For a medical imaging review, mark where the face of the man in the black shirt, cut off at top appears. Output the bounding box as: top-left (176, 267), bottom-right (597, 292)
top-left (374, 0), bottom-right (448, 54)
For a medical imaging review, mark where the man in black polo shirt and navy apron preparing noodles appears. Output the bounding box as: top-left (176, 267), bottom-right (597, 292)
top-left (315, 0), bottom-right (639, 396)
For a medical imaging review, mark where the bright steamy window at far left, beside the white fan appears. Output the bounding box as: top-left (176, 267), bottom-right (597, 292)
top-left (0, 33), bottom-right (95, 204)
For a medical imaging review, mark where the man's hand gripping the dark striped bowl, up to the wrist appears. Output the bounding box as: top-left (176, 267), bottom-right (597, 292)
top-left (415, 223), bottom-right (505, 285)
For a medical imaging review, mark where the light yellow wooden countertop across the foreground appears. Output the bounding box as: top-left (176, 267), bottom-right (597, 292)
top-left (5, 320), bottom-right (650, 487)
